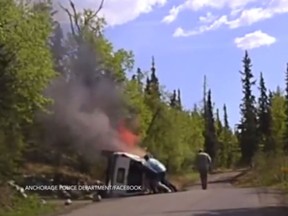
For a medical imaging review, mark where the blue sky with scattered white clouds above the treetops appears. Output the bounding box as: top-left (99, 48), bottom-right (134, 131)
top-left (61, 0), bottom-right (288, 125)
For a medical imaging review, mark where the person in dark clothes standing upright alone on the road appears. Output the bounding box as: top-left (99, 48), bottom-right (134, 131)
top-left (196, 149), bottom-right (212, 190)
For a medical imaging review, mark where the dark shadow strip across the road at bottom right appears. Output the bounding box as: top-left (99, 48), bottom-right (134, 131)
top-left (165, 207), bottom-right (288, 216)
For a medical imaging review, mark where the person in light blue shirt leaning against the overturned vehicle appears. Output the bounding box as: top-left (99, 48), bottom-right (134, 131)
top-left (144, 154), bottom-right (177, 192)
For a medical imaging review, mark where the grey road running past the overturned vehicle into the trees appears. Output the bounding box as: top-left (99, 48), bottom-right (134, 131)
top-left (58, 172), bottom-right (288, 216)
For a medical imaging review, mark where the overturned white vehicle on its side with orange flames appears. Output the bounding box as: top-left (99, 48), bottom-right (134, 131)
top-left (98, 110), bottom-right (175, 197)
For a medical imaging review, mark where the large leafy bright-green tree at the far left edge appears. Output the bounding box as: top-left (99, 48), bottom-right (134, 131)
top-left (0, 0), bottom-right (55, 179)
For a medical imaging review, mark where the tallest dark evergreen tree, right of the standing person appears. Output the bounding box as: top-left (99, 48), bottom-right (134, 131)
top-left (239, 51), bottom-right (258, 164)
